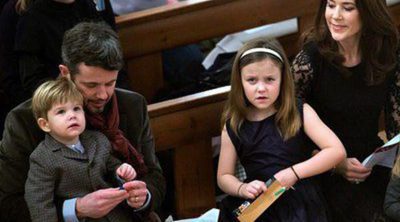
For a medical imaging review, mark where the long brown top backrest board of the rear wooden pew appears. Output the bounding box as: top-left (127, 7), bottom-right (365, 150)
top-left (117, 0), bottom-right (318, 58)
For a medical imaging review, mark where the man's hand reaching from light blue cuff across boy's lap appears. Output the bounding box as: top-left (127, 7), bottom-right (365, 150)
top-left (76, 188), bottom-right (129, 218)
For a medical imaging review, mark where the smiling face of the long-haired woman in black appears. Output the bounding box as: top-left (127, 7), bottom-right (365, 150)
top-left (325, 0), bottom-right (362, 42)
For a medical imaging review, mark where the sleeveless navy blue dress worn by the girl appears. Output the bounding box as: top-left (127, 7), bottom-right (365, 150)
top-left (221, 104), bottom-right (327, 222)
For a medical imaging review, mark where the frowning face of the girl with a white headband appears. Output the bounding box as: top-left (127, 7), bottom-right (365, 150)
top-left (241, 58), bottom-right (281, 118)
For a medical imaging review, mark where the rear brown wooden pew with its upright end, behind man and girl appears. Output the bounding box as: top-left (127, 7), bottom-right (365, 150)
top-left (117, 0), bottom-right (318, 102)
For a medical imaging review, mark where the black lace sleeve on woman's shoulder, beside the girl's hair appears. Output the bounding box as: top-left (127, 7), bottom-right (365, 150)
top-left (291, 50), bottom-right (314, 102)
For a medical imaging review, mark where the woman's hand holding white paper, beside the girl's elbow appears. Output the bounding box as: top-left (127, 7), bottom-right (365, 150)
top-left (335, 158), bottom-right (372, 183)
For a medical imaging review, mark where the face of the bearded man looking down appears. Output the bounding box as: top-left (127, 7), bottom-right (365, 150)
top-left (72, 63), bottom-right (118, 113)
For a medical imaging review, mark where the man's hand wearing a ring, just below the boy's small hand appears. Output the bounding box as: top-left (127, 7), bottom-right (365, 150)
top-left (124, 180), bottom-right (147, 208)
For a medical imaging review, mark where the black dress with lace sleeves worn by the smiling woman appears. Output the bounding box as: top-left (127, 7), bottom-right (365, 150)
top-left (292, 44), bottom-right (400, 222)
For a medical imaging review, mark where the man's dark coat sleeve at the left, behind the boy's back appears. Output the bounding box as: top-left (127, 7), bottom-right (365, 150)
top-left (0, 102), bottom-right (44, 222)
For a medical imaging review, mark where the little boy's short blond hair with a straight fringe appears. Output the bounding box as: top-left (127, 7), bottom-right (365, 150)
top-left (32, 77), bottom-right (83, 119)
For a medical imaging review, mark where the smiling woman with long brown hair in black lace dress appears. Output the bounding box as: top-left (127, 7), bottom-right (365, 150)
top-left (292, 0), bottom-right (400, 221)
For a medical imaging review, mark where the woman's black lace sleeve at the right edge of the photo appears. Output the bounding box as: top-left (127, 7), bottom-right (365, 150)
top-left (385, 61), bottom-right (400, 139)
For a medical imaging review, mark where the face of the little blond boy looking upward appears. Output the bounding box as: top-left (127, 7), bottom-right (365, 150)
top-left (38, 101), bottom-right (86, 145)
